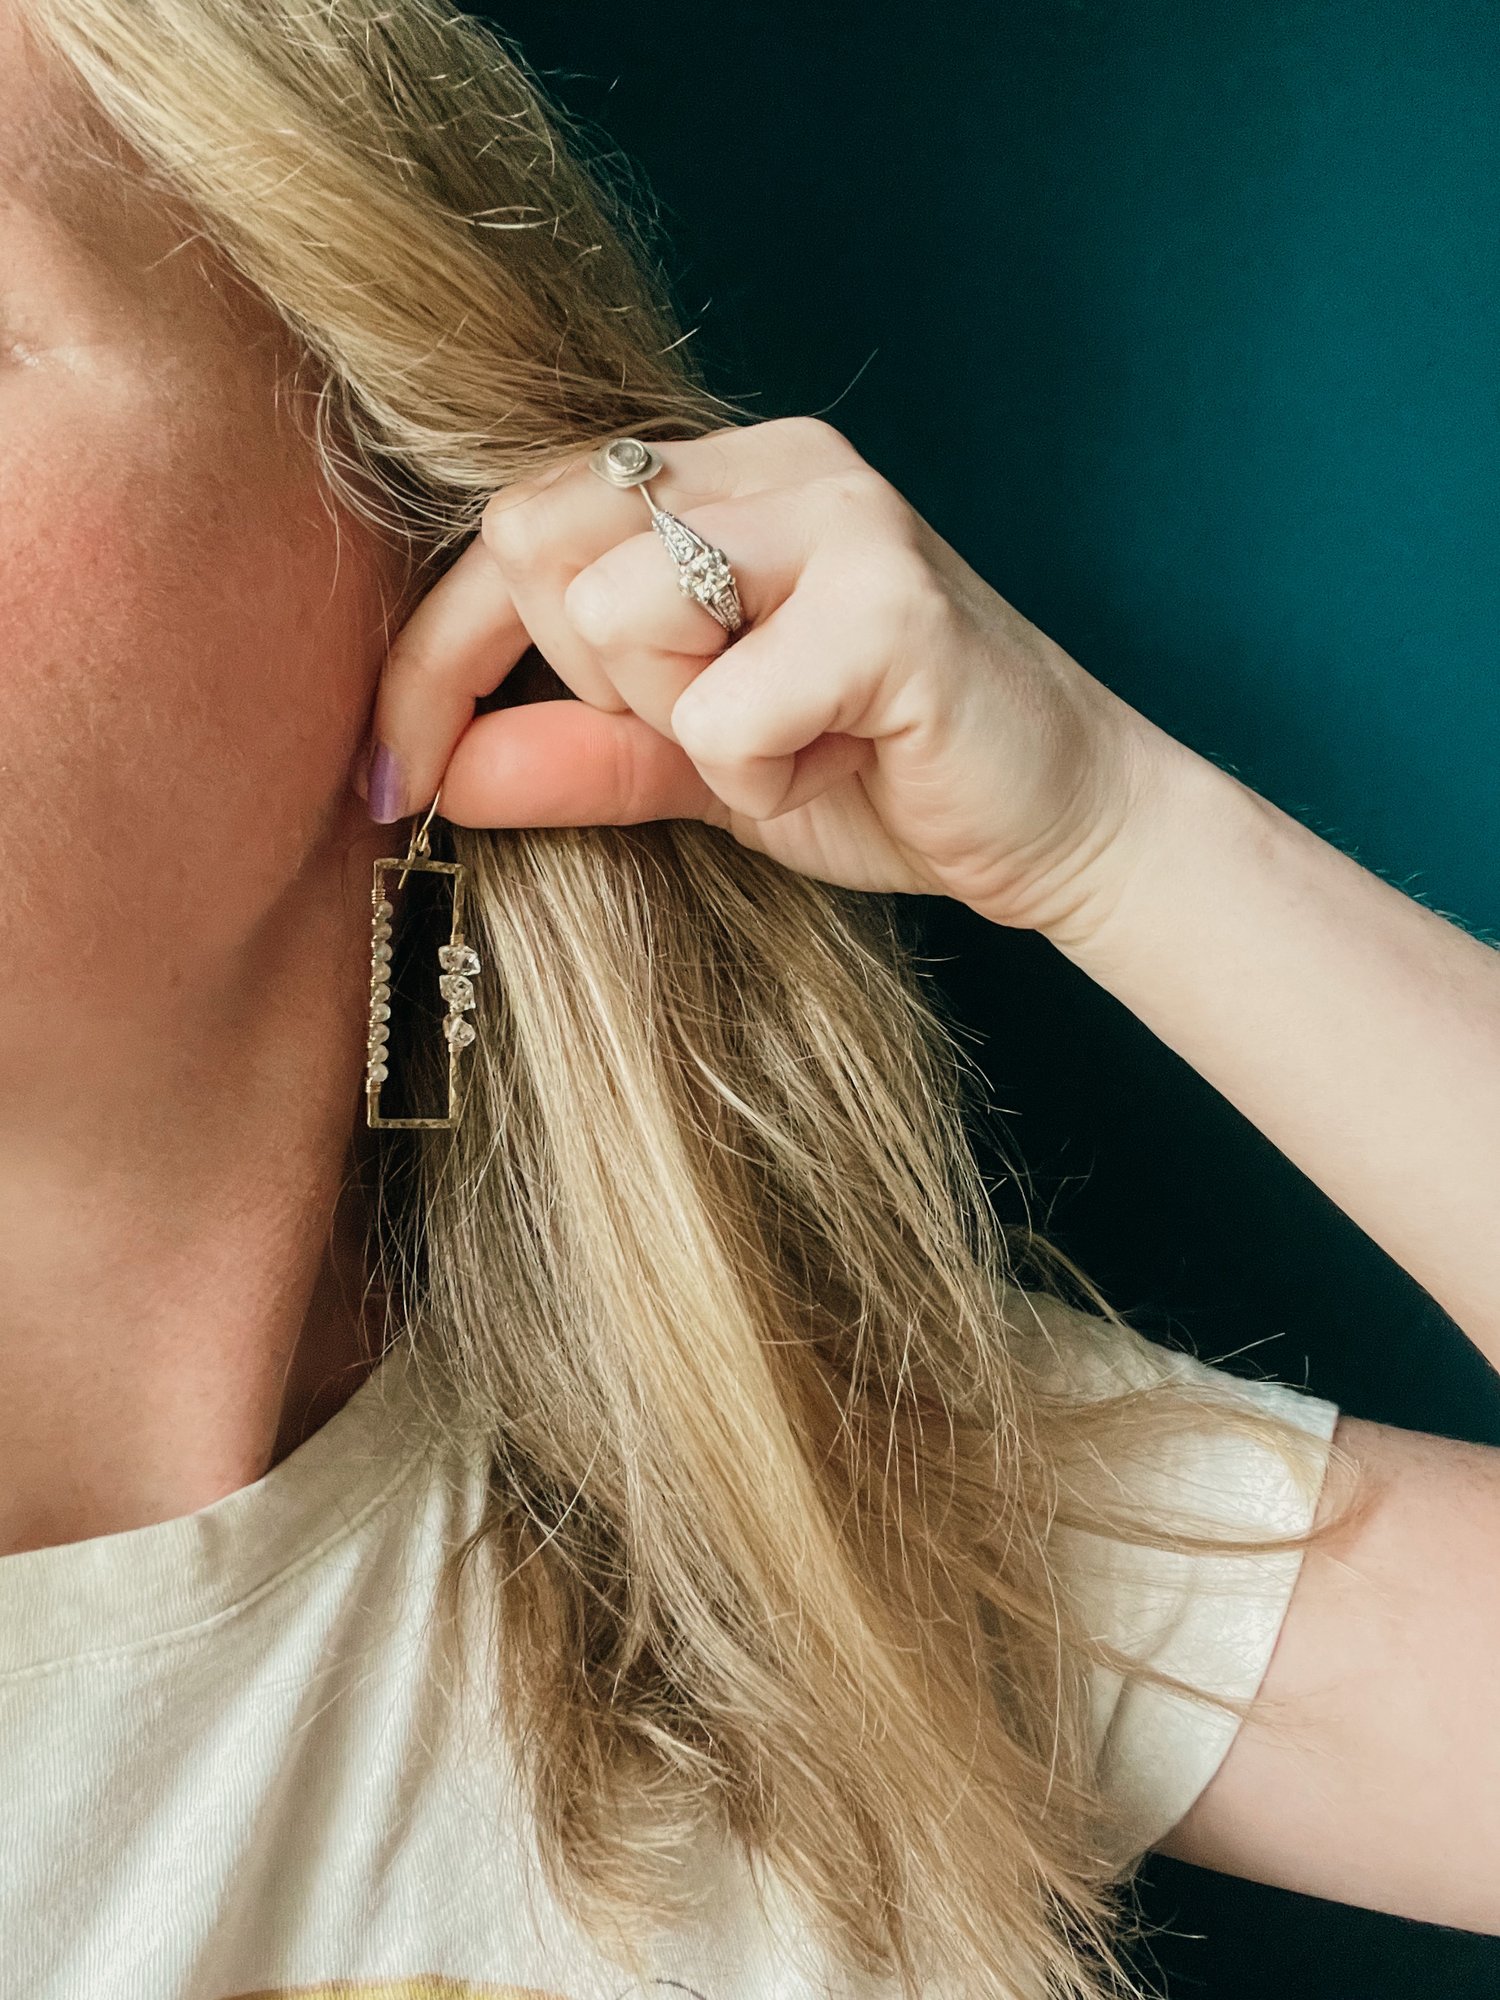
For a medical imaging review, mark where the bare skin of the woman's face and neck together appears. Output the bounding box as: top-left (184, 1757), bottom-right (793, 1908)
top-left (0, 0), bottom-right (418, 1556)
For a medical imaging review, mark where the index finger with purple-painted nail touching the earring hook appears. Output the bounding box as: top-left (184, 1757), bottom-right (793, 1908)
top-left (358, 536), bottom-right (532, 826)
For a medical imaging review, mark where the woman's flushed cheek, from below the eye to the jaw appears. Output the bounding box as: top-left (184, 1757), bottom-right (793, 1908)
top-left (0, 380), bottom-right (396, 982)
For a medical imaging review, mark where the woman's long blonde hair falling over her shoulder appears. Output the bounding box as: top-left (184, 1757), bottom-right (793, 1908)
top-left (28, 0), bottom-right (1360, 2000)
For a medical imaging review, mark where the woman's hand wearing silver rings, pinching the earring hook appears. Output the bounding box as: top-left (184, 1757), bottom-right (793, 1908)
top-left (358, 418), bottom-right (1172, 932)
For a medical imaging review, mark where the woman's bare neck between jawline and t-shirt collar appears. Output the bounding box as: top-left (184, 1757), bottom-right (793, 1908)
top-left (0, 830), bottom-right (400, 1554)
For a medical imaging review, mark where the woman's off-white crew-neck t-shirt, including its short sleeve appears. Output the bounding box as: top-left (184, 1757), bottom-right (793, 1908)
top-left (0, 1320), bottom-right (1338, 2000)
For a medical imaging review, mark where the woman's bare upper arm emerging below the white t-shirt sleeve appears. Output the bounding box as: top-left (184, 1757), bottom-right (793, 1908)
top-left (1158, 1416), bottom-right (1500, 1934)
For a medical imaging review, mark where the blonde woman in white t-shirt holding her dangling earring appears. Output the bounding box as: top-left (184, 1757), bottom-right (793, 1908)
top-left (0, 0), bottom-right (1500, 2000)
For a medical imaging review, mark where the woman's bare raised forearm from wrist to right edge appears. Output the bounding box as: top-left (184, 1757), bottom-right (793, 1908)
top-left (1046, 732), bottom-right (1500, 1368)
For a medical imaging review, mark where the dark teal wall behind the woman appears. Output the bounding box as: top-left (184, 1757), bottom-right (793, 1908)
top-left (496, 0), bottom-right (1500, 2000)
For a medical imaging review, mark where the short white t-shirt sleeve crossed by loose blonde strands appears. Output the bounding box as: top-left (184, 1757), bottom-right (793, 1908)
top-left (1058, 1322), bottom-right (1338, 1852)
